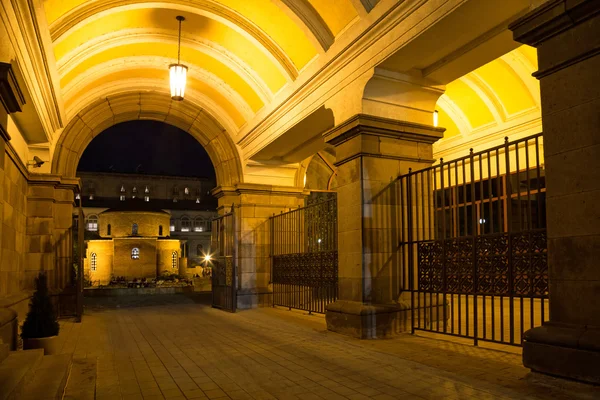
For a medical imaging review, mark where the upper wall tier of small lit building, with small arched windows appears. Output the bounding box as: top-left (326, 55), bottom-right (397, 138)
top-left (98, 211), bottom-right (170, 238)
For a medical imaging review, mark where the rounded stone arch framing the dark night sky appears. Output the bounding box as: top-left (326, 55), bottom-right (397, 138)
top-left (52, 91), bottom-right (243, 186)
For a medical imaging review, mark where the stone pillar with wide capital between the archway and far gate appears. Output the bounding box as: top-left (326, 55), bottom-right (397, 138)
top-left (213, 183), bottom-right (307, 309)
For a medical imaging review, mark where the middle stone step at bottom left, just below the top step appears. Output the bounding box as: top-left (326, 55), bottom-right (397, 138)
top-left (15, 354), bottom-right (71, 400)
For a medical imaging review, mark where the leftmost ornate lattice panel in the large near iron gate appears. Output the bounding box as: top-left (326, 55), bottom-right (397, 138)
top-left (418, 241), bottom-right (444, 292)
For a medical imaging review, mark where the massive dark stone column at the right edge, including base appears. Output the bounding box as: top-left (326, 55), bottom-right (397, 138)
top-left (510, 0), bottom-right (600, 383)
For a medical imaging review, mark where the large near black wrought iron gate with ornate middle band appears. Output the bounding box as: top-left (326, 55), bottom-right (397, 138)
top-left (394, 134), bottom-right (549, 345)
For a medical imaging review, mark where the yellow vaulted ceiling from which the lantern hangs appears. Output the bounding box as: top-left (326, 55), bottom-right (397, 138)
top-left (44, 0), bottom-right (359, 128)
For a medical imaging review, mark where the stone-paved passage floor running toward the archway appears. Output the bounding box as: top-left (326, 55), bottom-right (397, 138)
top-left (55, 295), bottom-right (600, 400)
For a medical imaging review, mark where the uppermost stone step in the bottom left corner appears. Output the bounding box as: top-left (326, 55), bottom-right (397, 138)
top-left (0, 349), bottom-right (44, 400)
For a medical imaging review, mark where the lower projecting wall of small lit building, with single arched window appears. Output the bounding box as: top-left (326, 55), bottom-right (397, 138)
top-left (113, 238), bottom-right (157, 279)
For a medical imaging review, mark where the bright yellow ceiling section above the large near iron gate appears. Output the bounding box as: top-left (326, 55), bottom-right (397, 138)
top-left (437, 46), bottom-right (540, 141)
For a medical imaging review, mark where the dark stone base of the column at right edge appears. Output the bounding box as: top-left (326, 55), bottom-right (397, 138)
top-left (523, 322), bottom-right (600, 384)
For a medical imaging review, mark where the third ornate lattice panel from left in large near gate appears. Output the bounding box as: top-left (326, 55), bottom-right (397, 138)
top-left (477, 234), bottom-right (510, 295)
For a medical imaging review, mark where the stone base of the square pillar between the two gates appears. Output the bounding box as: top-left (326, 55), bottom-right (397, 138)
top-left (325, 300), bottom-right (411, 339)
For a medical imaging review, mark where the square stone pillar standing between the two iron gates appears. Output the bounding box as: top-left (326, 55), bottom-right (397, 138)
top-left (324, 114), bottom-right (444, 338)
